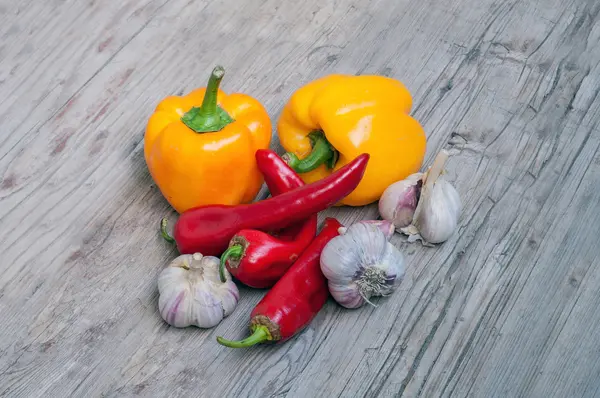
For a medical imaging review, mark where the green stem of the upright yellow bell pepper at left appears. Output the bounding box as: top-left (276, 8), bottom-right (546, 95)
top-left (181, 65), bottom-right (233, 133)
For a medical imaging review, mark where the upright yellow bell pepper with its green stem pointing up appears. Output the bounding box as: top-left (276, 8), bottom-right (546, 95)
top-left (144, 66), bottom-right (272, 213)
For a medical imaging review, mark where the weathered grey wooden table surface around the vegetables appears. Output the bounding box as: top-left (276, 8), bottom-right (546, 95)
top-left (0, 0), bottom-right (600, 398)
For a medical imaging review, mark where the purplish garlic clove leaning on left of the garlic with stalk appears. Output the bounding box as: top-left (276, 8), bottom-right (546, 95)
top-left (378, 173), bottom-right (423, 230)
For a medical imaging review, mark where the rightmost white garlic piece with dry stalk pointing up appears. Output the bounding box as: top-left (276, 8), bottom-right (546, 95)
top-left (401, 150), bottom-right (462, 244)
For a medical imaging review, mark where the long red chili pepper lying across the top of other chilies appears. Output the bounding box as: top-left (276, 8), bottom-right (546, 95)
top-left (162, 153), bottom-right (369, 256)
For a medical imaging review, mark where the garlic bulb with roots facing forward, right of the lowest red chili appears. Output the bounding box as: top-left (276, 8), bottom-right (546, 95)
top-left (320, 222), bottom-right (404, 308)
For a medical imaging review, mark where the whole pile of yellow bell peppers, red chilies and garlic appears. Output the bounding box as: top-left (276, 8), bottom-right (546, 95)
top-left (144, 66), bottom-right (462, 348)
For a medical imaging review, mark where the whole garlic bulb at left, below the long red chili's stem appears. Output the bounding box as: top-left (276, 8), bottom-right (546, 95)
top-left (158, 253), bottom-right (240, 328)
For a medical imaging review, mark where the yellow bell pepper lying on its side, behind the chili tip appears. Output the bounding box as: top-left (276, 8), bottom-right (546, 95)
top-left (277, 74), bottom-right (426, 206)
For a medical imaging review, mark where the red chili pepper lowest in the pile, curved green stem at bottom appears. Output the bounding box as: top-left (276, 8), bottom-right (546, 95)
top-left (217, 218), bottom-right (342, 348)
